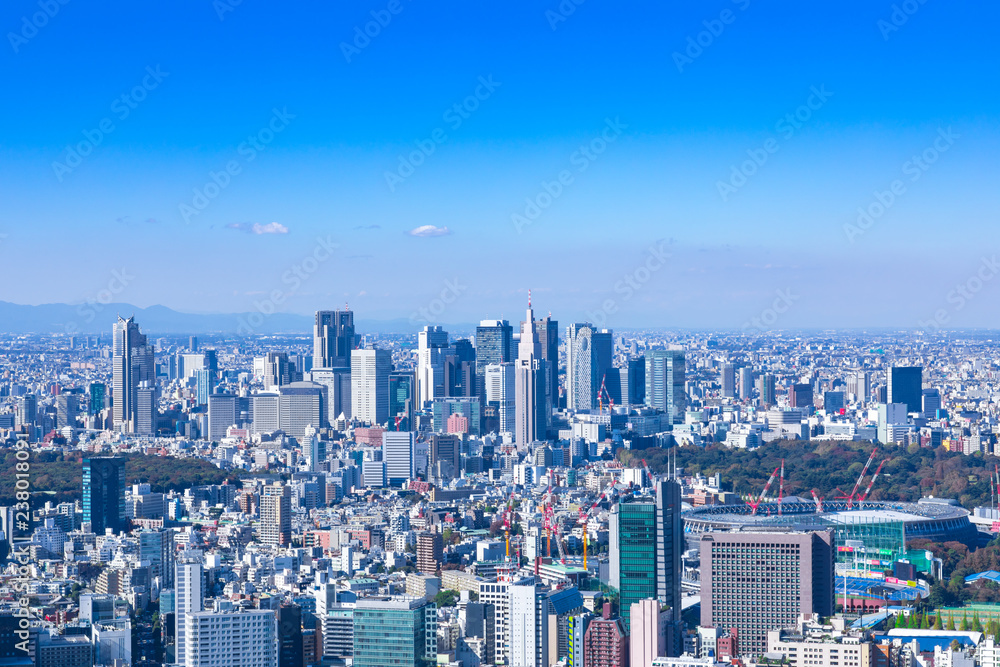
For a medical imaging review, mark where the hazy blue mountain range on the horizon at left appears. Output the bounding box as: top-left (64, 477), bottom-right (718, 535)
top-left (0, 301), bottom-right (475, 338)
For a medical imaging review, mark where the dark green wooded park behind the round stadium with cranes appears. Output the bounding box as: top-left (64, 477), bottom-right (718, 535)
top-left (619, 440), bottom-right (1000, 510)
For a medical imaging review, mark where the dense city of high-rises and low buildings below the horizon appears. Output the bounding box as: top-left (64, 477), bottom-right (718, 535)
top-left (0, 304), bottom-right (1000, 667)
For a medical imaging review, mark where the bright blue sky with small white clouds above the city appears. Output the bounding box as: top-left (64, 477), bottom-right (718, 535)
top-left (0, 0), bottom-right (1000, 328)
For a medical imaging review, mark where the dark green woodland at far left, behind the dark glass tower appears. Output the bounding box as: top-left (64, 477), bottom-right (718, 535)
top-left (0, 450), bottom-right (239, 505)
